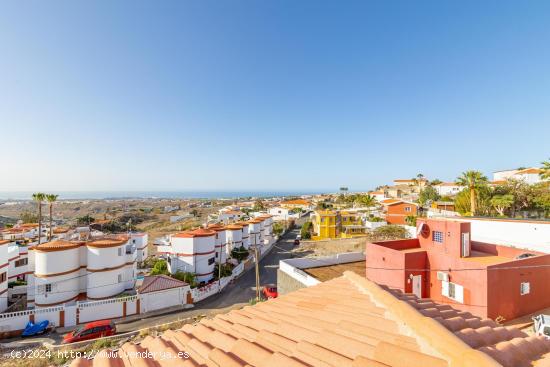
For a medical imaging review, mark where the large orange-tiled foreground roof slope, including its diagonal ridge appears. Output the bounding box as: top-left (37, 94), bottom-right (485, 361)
top-left (71, 272), bottom-right (512, 367)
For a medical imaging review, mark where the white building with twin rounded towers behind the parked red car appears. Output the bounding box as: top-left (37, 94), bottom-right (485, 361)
top-left (27, 235), bottom-right (137, 307)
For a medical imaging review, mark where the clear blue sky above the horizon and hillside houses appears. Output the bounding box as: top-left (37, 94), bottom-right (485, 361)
top-left (0, 0), bottom-right (550, 191)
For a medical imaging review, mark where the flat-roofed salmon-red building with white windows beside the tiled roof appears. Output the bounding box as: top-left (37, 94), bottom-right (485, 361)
top-left (366, 218), bottom-right (550, 320)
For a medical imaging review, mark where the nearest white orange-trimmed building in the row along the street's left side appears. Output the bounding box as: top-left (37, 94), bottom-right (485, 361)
top-left (159, 228), bottom-right (217, 282)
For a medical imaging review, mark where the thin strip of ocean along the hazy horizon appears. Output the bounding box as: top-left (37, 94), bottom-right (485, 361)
top-left (0, 190), bottom-right (329, 201)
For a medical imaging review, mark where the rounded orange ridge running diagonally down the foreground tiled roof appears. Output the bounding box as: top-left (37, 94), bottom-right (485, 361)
top-left (344, 271), bottom-right (502, 367)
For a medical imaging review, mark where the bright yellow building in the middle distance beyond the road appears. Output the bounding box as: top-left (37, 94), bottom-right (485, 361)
top-left (312, 210), bottom-right (365, 240)
